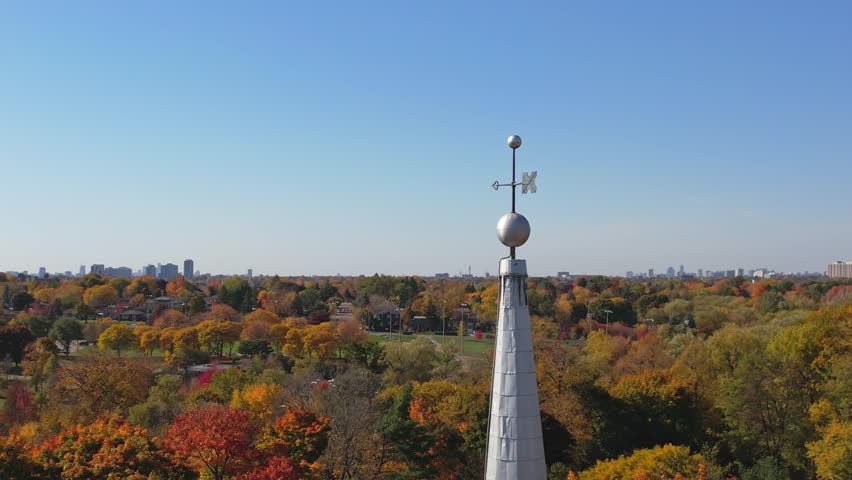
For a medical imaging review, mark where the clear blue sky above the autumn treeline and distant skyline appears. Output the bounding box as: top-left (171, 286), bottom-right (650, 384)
top-left (0, 0), bottom-right (852, 275)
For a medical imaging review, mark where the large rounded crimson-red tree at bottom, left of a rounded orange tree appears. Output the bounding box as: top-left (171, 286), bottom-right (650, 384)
top-left (165, 405), bottom-right (256, 480)
